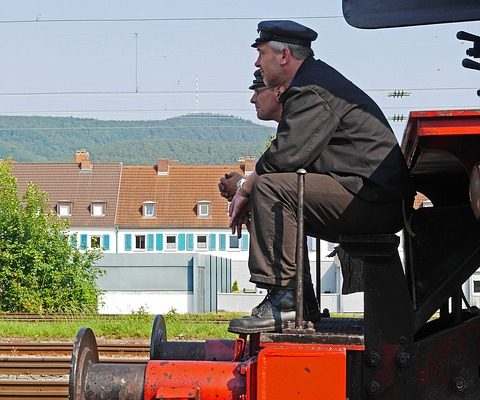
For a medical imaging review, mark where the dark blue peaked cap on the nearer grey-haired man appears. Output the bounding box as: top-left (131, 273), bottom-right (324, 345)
top-left (252, 20), bottom-right (318, 47)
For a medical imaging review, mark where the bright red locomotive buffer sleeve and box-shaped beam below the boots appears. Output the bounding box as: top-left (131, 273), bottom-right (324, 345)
top-left (144, 343), bottom-right (364, 400)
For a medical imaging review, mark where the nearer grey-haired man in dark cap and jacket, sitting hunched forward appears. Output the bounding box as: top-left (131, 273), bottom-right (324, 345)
top-left (229, 21), bottom-right (413, 333)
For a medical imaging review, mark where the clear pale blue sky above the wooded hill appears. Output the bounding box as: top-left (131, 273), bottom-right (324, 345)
top-left (0, 0), bottom-right (480, 140)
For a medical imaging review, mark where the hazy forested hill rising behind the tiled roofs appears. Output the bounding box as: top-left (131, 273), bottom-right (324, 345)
top-left (0, 114), bottom-right (275, 165)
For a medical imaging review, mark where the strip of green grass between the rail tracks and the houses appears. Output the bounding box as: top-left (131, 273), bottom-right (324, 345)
top-left (0, 313), bottom-right (243, 340)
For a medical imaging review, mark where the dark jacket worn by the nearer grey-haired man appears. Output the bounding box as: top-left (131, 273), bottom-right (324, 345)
top-left (256, 57), bottom-right (411, 202)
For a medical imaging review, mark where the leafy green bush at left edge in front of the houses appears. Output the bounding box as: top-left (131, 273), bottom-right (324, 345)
top-left (0, 160), bottom-right (102, 313)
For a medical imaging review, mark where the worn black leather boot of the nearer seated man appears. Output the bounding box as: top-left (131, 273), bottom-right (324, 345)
top-left (228, 289), bottom-right (296, 334)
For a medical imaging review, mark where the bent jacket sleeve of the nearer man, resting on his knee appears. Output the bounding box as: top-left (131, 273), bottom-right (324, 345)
top-left (255, 86), bottom-right (340, 175)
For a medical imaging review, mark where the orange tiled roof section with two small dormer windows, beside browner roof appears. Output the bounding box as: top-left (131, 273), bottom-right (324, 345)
top-left (117, 161), bottom-right (243, 228)
